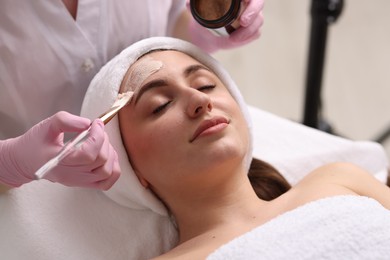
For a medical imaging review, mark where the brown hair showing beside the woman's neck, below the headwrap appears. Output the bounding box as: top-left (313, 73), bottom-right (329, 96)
top-left (248, 158), bottom-right (291, 201)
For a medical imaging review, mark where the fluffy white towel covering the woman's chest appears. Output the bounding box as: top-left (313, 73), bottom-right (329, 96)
top-left (207, 195), bottom-right (390, 260)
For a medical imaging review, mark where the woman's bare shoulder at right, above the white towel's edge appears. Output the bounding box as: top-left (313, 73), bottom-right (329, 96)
top-left (294, 162), bottom-right (390, 209)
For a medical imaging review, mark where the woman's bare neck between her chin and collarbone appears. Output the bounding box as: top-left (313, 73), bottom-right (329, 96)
top-left (172, 174), bottom-right (267, 244)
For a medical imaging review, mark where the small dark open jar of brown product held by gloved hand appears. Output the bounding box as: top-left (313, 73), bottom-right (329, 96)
top-left (190, 0), bottom-right (243, 36)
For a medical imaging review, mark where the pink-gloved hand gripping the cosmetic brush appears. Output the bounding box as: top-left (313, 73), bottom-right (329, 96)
top-left (0, 112), bottom-right (120, 190)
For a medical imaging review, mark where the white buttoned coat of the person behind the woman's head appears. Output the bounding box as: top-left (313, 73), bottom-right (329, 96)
top-left (0, 0), bottom-right (185, 139)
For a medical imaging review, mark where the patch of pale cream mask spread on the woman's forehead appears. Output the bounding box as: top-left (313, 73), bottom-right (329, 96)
top-left (122, 56), bottom-right (163, 92)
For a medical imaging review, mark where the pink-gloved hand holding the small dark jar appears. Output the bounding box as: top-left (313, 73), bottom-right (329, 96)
top-left (187, 0), bottom-right (264, 53)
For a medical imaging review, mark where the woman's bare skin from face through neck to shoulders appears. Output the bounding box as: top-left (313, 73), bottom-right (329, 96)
top-left (119, 51), bottom-right (390, 259)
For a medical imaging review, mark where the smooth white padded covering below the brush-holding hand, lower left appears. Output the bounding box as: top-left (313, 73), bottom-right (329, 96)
top-left (0, 180), bottom-right (177, 260)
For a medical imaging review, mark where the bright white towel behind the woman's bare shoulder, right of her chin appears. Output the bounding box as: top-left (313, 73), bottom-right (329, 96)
top-left (249, 107), bottom-right (389, 185)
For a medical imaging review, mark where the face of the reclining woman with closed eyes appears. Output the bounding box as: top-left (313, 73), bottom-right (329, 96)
top-left (119, 51), bottom-right (249, 199)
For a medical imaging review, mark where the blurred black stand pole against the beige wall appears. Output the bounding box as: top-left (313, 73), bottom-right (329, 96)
top-left (303, 0), bottom-right (344, 132)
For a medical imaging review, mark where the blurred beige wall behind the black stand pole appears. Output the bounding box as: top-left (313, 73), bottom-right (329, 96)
top-left (214, 0), bottom-right (390, 156)
